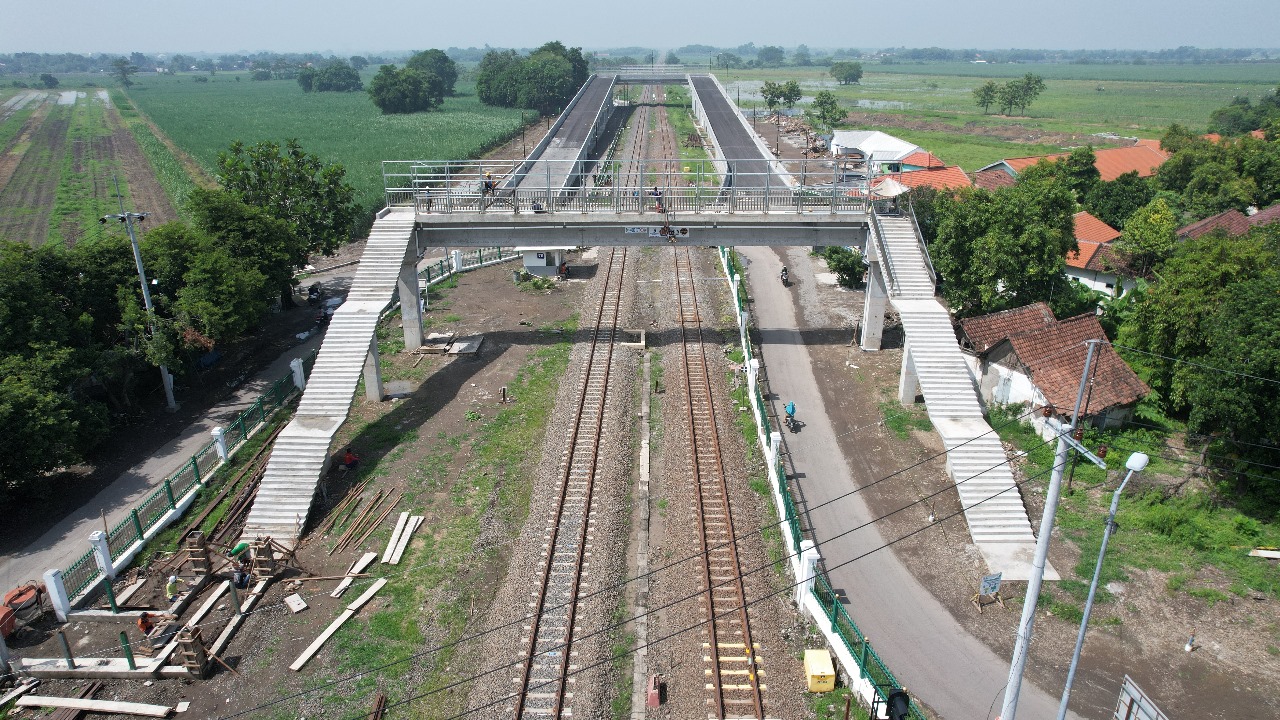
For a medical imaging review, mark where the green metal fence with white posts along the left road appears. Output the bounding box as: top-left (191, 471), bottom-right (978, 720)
top-left (75, 352), bottom-right (316, 571)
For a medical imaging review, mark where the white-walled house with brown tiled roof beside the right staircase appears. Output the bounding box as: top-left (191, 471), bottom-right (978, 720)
top-left (960, 304), bottom-right (1151, 427)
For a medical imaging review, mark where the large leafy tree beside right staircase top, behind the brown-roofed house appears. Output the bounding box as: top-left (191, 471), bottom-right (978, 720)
top-left (929, 178), bottom-right (1078, 316)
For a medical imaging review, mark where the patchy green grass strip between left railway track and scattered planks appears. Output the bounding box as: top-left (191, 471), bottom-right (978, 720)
top-left (330, 311), bottom-right (577, 717)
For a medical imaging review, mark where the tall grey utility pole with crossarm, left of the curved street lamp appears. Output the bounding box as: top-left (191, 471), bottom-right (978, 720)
top-left (1000, 340), bottom-right (1106, 720)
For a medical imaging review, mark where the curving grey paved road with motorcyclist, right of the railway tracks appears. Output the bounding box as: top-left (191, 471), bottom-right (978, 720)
top-left (739, 247), bottom-right (1079, 720)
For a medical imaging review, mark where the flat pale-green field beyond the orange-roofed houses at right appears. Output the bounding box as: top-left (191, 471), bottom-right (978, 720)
top-left (716, 63), bottom-right (1280, 170)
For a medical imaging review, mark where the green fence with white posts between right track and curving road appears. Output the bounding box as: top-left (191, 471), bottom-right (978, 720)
top-left (719, 247), bottom-right (925, 720)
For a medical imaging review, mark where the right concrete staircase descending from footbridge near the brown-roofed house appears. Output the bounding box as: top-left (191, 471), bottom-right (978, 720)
top-left (872, 217), bottom-right (1036, 580)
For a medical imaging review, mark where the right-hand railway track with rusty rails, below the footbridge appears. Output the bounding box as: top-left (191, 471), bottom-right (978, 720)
top-left (672, 247), bottom-right (764, 720)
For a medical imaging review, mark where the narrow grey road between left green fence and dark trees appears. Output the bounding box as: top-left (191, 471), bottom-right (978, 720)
top-left (0, 265), bottom-right (356, 592)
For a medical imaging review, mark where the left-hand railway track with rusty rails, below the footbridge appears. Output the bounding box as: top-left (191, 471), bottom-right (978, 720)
top-left (513, 247), bottom-right (627, 720)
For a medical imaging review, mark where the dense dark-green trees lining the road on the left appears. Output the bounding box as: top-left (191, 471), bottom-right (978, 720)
top-left (0, 141), bottom-right (358, 496)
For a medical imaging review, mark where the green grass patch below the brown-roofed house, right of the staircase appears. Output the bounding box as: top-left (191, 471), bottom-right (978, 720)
top-left (991, 407), bottom-right (1280, 602)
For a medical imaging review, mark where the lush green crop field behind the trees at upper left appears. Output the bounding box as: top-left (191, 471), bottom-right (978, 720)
top-left (128, 73), bottom-right (527, 208)
